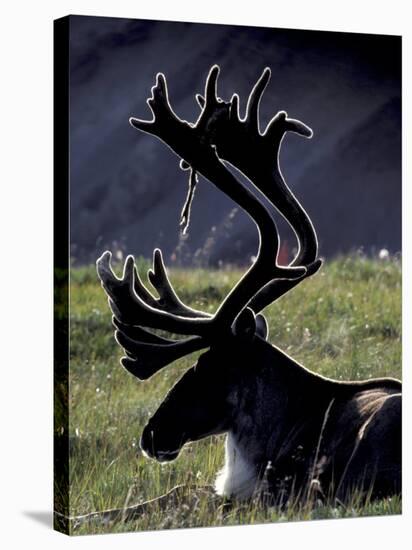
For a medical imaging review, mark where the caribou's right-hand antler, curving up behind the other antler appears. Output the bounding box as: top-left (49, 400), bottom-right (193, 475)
top-left (193, 66), bottom-right (322, 313)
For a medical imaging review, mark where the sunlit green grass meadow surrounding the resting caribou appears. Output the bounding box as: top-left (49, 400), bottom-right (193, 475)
top-left (62, 257), bottom-right (401, 534)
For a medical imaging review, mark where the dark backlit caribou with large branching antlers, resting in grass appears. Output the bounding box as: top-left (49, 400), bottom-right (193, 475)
top-left (97, 65), bottom-right (401, 500)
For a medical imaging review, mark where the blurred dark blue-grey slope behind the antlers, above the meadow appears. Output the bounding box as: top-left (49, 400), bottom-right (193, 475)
top-left (70, 16), bottom-right (401, 266)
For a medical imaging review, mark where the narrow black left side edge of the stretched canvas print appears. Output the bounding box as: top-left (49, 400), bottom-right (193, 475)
top-left (54, 17), bottom-right (70, 534)
